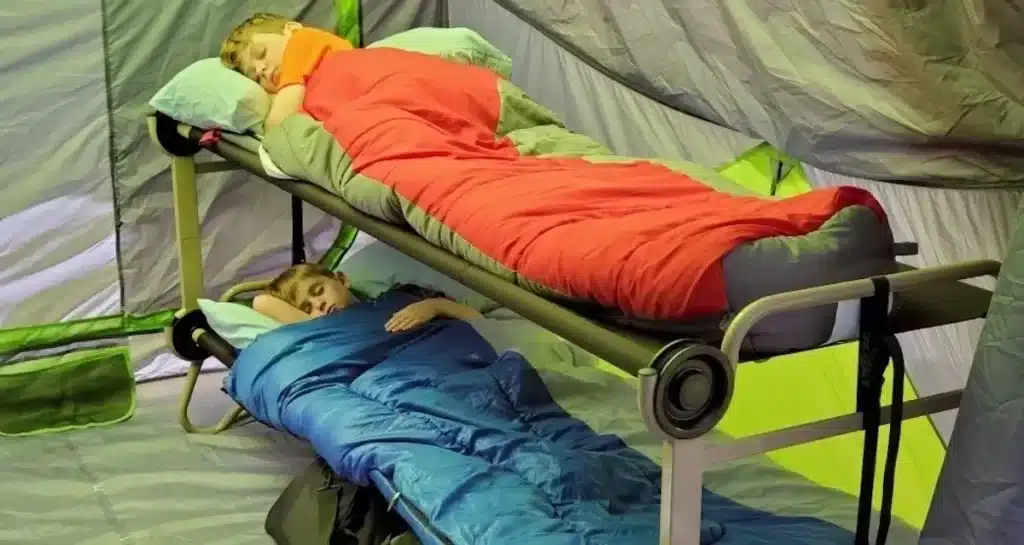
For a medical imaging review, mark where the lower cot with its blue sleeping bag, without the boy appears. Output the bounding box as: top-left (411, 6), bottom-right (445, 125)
top-left (192, 303), bottom-right (918, 545)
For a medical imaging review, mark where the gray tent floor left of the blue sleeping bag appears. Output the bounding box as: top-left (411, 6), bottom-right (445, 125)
top-left (0, 373), bottom-right (313, 545)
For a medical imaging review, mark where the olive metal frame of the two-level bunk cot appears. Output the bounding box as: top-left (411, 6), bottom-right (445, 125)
top-left (147, 114), bottom-right (1000, 545)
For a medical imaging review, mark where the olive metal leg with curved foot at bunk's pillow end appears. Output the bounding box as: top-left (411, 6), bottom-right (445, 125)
top-left (171, 156), bottom-right (243, 433)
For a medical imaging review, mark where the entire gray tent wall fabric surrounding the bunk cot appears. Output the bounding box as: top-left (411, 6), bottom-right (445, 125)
top-left (0, 0), bottom-right (1024, 545)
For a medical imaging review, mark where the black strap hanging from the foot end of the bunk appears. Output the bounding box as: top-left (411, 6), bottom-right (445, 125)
top-left (854, 277), bottom-right (904, 545)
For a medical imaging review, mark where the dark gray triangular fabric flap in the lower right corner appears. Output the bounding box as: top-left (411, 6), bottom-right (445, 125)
top-left (921, 201), bottom-right (1024, 545)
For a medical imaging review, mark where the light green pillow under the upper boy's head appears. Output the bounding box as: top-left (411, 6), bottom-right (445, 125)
top-left (150, 58), bottom-right (270, 134)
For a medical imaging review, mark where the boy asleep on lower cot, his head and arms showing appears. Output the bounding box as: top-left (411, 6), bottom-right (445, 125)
top-left (253, 263), bottom-right (481, 333)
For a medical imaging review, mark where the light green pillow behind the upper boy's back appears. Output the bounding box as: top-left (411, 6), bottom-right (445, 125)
top-left (367, 27), bottom-right (512, 79)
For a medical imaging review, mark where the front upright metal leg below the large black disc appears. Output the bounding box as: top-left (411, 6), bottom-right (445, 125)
top-left (658, 437), bottom-right (705, 545)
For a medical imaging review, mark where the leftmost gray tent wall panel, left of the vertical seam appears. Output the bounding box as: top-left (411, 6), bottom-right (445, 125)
top-left (0, 0), bottom-right (121, 328)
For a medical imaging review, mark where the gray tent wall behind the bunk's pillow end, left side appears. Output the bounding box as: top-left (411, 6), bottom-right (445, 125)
top-left (0, 0), bottom-right (445, 379)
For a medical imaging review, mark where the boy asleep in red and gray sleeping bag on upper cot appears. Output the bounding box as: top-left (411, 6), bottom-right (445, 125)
top-left (214, 14), bottom-right (888, 323)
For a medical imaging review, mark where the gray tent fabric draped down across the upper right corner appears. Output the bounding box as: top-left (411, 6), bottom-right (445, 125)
top-left (485, 0), bottom-right (1024, 187)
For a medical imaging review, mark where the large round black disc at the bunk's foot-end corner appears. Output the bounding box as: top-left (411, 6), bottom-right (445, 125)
top-left (651, 343), bottom-right (735, 439)
